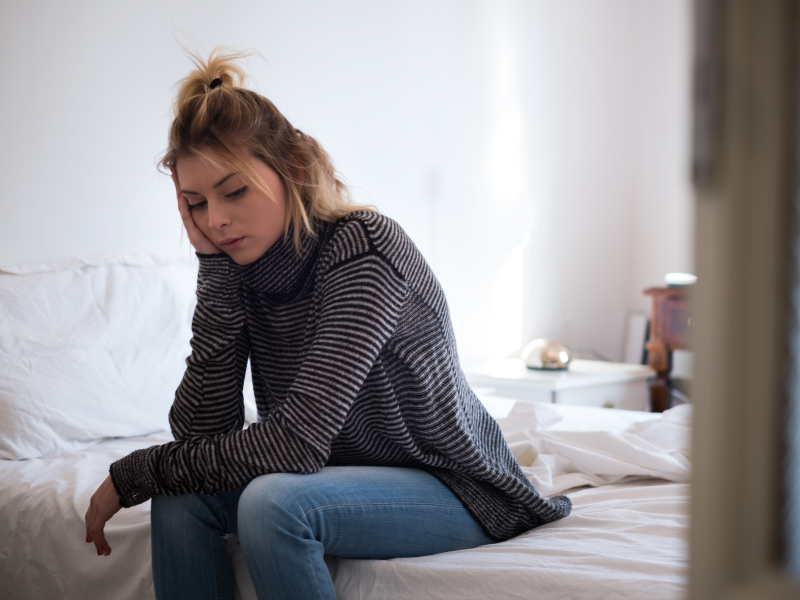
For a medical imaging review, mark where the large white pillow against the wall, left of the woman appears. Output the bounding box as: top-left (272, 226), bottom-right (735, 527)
top-left (0, 255), bottom-right (197, 459)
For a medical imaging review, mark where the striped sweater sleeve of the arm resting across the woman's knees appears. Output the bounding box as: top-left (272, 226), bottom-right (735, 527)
top-left (111, 252), bottom-right (407, 506)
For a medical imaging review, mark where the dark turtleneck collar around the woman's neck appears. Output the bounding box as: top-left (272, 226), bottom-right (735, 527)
top-left (243, 221), bottom-right (333, 297)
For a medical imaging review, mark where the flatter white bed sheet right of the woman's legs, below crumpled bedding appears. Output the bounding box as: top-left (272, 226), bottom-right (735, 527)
top-left (318, 481), bottom-right (689, 600)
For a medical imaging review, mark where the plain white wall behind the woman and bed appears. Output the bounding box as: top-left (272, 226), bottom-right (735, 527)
top-left (0, 0), bottom-right (692, 363)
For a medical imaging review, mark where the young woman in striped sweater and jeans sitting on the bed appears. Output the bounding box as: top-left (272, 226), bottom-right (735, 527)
top-left (86, 51), bottom-right (570, 600)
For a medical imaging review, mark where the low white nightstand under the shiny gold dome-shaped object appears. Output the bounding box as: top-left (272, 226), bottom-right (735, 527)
top-left (465, 358), bottom-right (655, 410)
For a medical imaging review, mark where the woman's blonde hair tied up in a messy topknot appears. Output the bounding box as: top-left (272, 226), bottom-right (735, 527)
top-left (159, 48), bottom-right (374, 252)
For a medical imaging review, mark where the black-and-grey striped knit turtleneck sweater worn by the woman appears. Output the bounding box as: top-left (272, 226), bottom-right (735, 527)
top-left (111, 212), bottom-right (571, 540)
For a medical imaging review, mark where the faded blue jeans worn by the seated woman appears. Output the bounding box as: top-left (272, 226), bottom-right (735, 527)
top-left (151, 467), bottom-right (492, 600)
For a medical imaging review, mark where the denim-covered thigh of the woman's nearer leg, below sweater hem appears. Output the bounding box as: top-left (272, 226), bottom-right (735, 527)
top-left (239, 467), bottom-right (492, 559)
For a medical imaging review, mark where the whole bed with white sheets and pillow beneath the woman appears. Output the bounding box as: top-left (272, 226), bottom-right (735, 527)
top-left (0, 257), bottom-right (691, 600)
